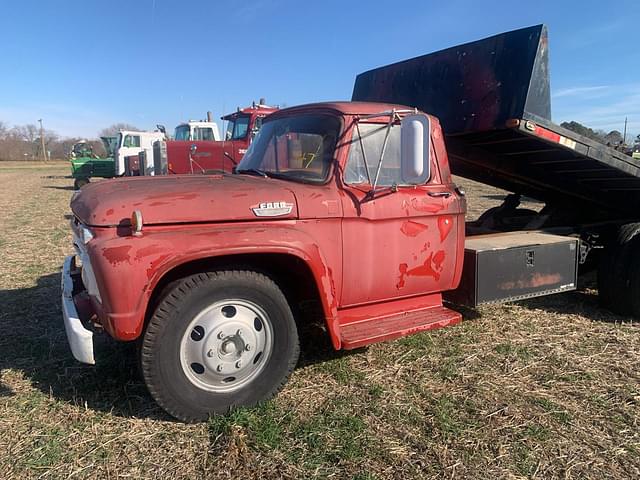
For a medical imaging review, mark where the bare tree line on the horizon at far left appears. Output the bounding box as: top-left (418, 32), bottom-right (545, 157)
top-left (0, 121), bottom-right (139, 160)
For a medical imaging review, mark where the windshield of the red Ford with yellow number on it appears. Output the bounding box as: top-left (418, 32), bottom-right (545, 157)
top-left (237, 114), bottom-right (340, 183)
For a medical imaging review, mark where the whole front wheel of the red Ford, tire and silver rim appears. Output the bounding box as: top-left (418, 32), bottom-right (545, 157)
top-left (140, 271), bottom-right (299, 421)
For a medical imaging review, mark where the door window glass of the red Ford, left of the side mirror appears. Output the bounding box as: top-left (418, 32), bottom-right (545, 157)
top-left (344, 123), bottom-right (403, 186)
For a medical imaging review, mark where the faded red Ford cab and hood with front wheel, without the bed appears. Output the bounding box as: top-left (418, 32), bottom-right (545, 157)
top-left (63, 102), bottom-right (466, 420)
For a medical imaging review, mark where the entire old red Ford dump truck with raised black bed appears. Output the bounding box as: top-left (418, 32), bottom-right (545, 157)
top-left (62, 27), bottom-right (640, 421)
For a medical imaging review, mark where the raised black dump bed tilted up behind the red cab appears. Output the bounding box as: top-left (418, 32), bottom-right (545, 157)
top-left (352, 25), bottom-right (640, 222)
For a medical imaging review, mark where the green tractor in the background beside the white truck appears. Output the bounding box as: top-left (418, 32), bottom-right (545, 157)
top-left (69, 137), bottom-right (118, 190)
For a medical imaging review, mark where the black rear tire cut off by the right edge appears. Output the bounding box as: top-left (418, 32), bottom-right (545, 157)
top-left (598, 223), bottom-right (640, 315)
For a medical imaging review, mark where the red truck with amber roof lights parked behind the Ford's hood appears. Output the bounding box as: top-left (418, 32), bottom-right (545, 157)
top-left (152, 99), bottom-right (277, 175)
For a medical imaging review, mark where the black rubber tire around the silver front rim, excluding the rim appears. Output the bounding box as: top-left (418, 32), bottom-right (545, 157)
top-left (140, 271), bottom-right (300, 422)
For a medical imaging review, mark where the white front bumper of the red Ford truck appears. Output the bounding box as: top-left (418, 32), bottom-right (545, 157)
top-left (62, 255), bottom-right (96, 365)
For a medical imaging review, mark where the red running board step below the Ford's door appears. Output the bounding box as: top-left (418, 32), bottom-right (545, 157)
top-left (340, 305), bottom-right (462, 350)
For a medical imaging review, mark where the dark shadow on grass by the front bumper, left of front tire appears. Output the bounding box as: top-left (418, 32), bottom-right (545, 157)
top-left (0, 273), bottom-right (170, 420)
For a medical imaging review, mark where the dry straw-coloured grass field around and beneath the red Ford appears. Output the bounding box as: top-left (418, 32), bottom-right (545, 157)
top-left (0, 163), bottom-right (640, 480)
